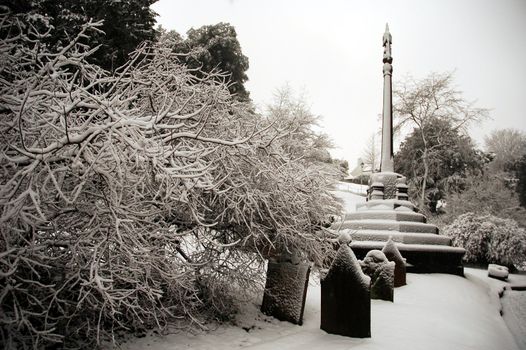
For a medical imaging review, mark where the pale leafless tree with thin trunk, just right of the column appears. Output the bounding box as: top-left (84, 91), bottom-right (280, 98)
top-left (393, 73), bottom-right (489, 208)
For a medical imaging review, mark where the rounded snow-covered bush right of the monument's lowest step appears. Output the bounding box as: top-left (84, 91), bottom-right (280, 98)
top-left (443, 212), bottom-right (526, 267)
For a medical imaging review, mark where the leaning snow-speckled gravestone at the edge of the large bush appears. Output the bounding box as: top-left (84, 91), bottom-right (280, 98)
top-left (261, 254), bottom-right (310, 325)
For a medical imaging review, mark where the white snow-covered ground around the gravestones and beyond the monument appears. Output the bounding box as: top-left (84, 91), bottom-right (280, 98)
top-left (122, 187), bottom-right (526, 350)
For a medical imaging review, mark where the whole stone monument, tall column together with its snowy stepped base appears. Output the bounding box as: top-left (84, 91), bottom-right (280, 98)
top-left (332, 26), bottom-right (466, 276)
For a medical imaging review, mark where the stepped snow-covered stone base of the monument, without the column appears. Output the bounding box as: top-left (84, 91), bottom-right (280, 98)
top-left (331, 173), bottom-right (465, 276)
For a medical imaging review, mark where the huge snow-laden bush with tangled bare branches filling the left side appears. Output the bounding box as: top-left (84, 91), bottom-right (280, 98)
top-left (0, 14), bottom-right (340, 348)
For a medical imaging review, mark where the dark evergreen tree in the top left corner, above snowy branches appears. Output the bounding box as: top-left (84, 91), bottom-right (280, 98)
top-left (6, 0), bottom-right (157, 71)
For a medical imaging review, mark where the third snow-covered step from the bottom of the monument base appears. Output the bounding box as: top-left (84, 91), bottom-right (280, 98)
top-left (331, 219), bottom-right (438, 234)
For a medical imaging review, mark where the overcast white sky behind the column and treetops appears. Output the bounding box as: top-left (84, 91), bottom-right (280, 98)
top-left (152, 0), bottom-right (526, 167)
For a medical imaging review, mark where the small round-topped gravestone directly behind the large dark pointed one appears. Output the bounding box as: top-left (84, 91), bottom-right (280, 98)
top-left (360, 250), bottom-right (395, 301)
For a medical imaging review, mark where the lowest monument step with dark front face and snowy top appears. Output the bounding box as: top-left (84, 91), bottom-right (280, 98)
top-left (351, 241), bottom-right (466, 276)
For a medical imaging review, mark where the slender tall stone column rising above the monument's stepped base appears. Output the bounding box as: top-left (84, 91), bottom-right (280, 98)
top-left (380, 24), bottom-right (394, 172)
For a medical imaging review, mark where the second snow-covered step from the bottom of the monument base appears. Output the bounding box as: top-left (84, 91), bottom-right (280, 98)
top-left (349, 230), bottom-right (451, 246)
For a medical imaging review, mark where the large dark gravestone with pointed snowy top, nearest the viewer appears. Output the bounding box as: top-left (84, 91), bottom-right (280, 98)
top-left (320, 244), bottom-right (371, 338)
